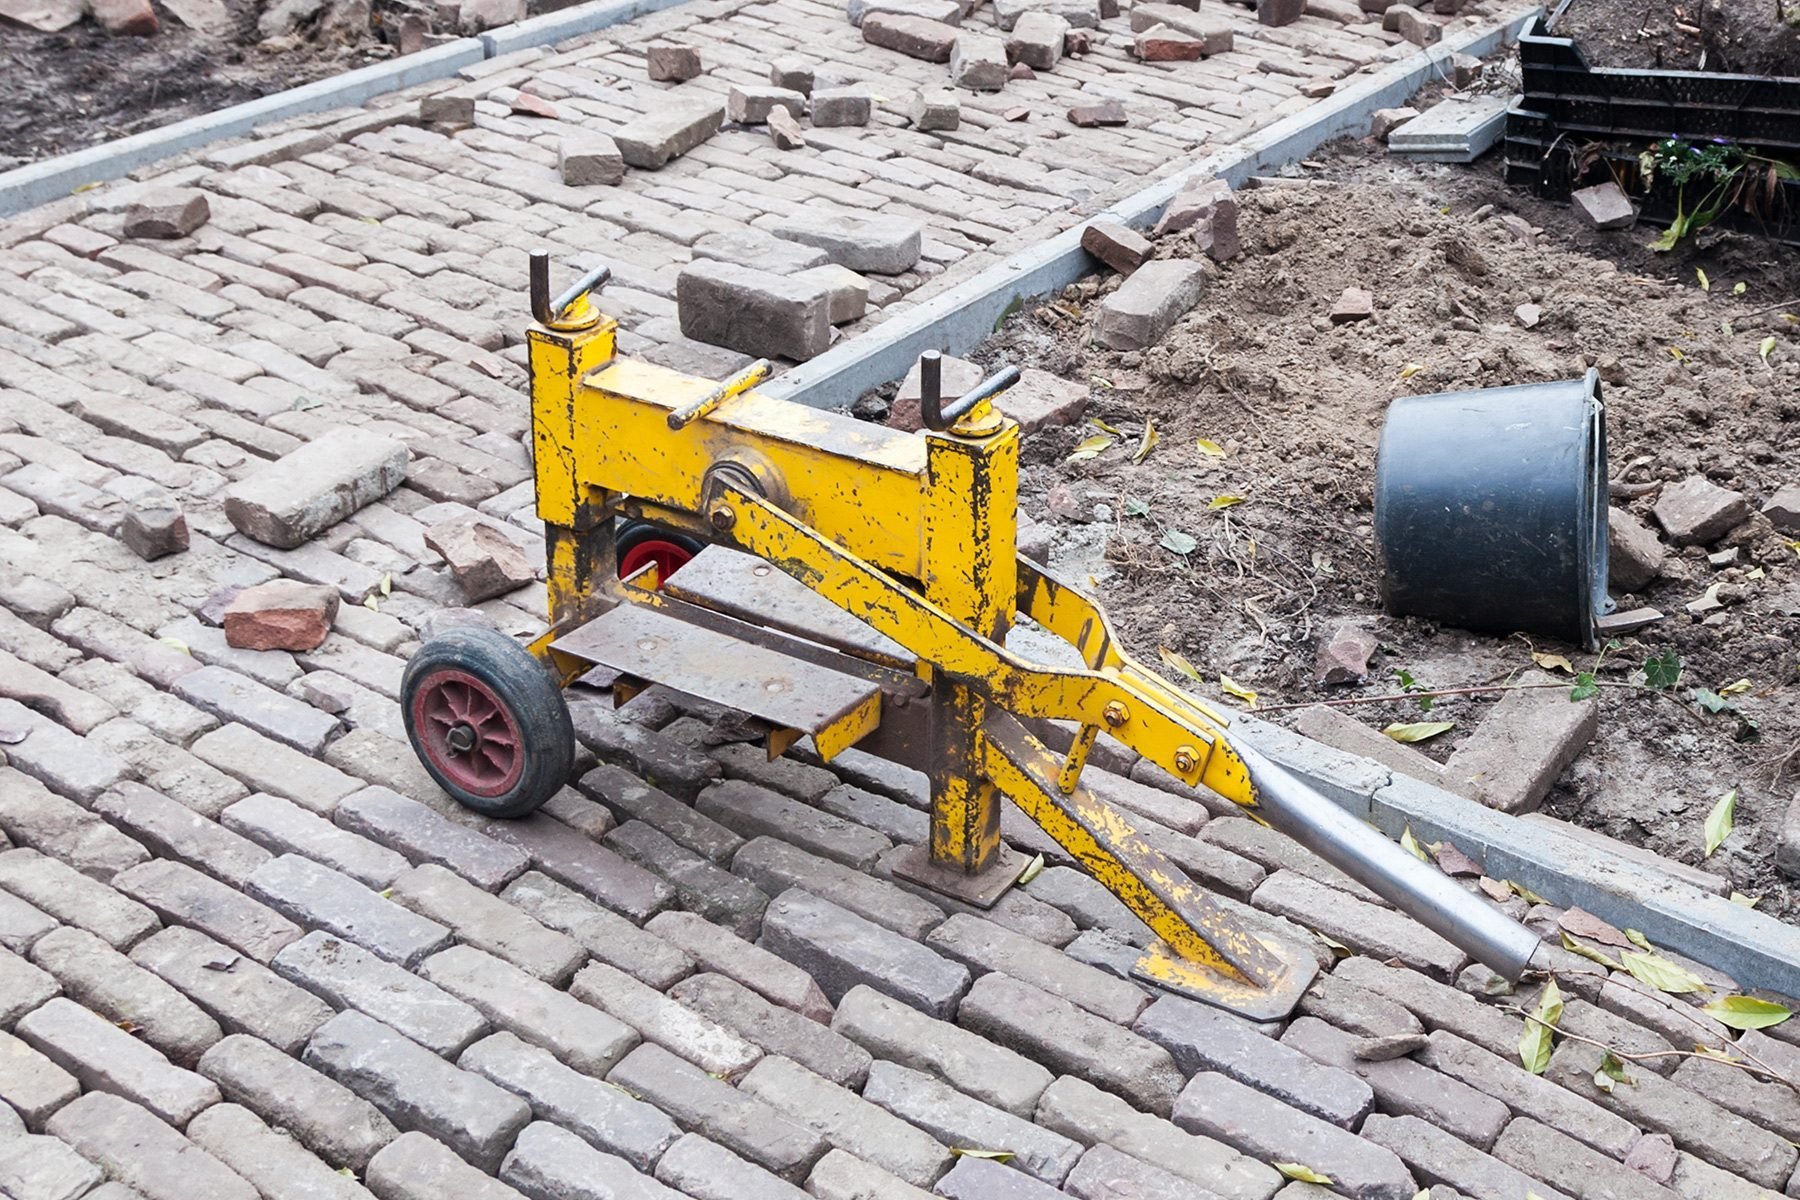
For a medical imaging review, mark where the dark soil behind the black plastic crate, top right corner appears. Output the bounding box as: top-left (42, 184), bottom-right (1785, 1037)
top-left (1550, 0), bottom-right (1800, 76)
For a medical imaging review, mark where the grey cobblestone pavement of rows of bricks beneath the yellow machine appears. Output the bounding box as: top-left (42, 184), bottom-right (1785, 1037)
top-left (0, 0), bottom-right (1800, 1200)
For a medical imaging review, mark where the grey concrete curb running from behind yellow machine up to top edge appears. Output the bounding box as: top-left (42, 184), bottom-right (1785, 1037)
top-left (758, 7), bottom-right (1543, 408)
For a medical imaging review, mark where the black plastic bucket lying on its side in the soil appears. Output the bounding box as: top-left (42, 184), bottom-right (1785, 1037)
top-left (1375, 371), bottom-right (1609, 649)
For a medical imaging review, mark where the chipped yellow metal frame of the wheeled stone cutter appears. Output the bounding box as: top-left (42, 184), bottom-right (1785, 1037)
top-left (527, 302), bottom-right (1316, 1016)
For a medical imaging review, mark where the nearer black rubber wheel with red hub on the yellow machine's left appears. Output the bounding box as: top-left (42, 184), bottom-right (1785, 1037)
top-left (400, 626), bottom-right (574, 817)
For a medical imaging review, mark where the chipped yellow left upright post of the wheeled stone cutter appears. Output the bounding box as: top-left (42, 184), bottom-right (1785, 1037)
top-left (526, 317), bottom-right (617, 626)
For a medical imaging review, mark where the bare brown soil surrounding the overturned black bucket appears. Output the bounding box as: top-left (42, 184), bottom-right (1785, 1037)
top-left (976, 142), bottom-right (1800, 916)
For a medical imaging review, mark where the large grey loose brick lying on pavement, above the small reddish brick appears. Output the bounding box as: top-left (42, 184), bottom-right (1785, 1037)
top-left (225, 428), bottom-right (407, 551)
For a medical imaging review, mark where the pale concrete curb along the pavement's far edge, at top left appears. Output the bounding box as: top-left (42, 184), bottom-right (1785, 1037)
top-left (0, 0), bottom-right (684, 218)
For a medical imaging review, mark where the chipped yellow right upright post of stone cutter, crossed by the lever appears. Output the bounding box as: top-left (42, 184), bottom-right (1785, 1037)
top-left (923, 420), bottom-right (1019, 874)
